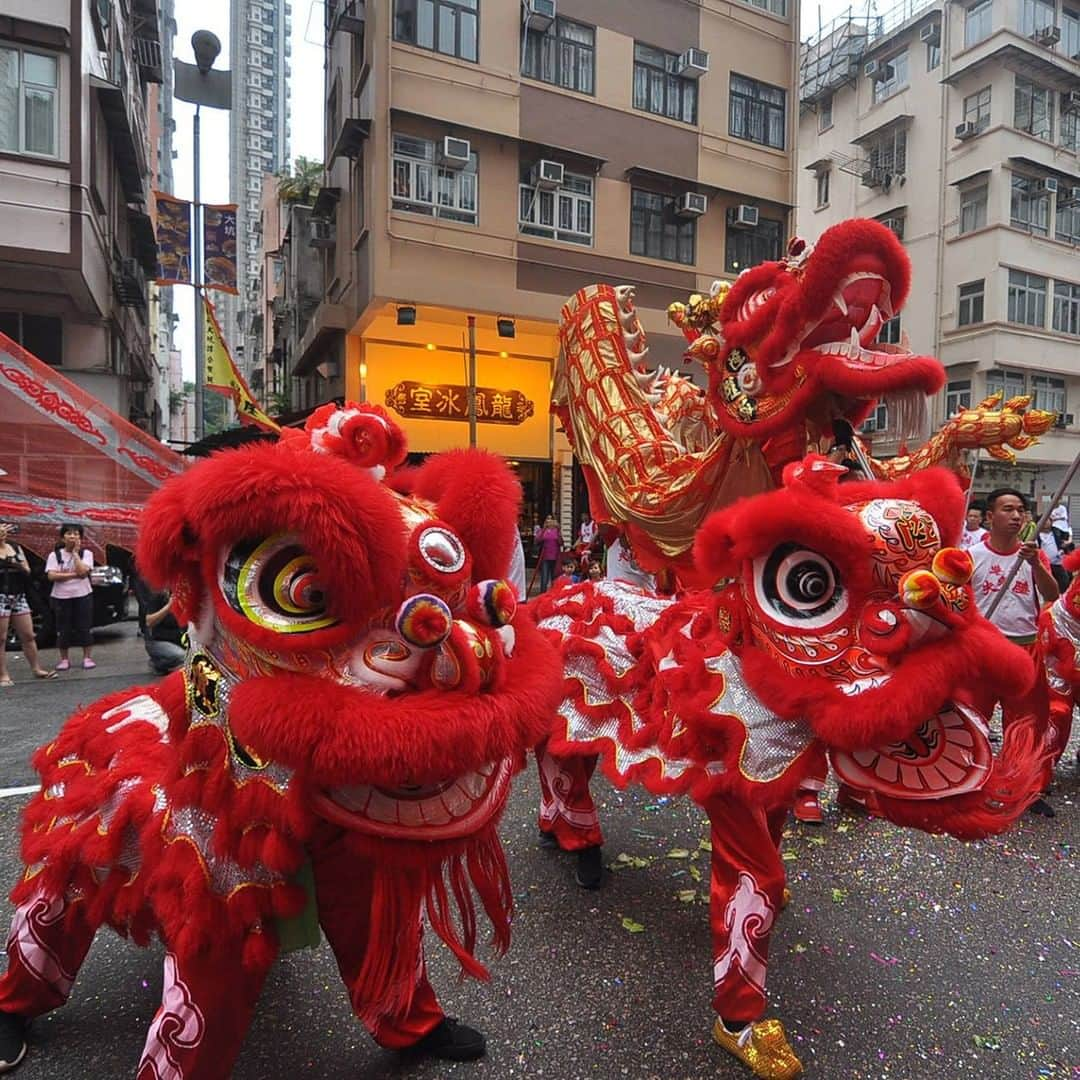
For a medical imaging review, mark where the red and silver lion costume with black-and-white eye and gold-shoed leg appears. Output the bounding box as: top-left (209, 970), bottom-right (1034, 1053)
top-left (535, 456), bottom-right (1045, 1080)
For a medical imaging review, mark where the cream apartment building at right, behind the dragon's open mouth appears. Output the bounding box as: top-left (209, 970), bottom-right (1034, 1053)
top-left (798, 0), bottom-right (1080, 507)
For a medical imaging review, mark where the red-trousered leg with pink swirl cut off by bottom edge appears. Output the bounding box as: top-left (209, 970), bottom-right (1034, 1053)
top-left (136, 949), bottom-right (270, 1080)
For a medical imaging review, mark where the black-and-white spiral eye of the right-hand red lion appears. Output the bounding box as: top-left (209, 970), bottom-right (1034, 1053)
top-left (754, 543), bottom-right (848, 629)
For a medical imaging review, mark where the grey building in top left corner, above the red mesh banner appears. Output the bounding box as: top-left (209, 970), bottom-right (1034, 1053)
top-left (0, 0), bottom-right (162, 430)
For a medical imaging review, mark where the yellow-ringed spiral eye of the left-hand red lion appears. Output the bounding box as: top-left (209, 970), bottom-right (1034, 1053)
top-left (221, 536), bottom-right (337, 634)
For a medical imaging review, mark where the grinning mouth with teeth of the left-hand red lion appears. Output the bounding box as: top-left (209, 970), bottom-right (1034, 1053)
top-left (315, 757), bottom-right (513, 840)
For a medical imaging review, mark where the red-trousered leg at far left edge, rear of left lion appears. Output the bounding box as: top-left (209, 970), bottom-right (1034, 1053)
top-left (0, 893), bottom-right (97, 1017)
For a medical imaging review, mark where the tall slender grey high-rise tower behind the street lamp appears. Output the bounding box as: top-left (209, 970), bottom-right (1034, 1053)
top-left (219, 0), bottom-right (293, 370)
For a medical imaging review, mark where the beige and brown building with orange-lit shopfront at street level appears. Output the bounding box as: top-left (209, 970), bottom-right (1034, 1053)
top-left (280, 0), bottom-right (798, 520)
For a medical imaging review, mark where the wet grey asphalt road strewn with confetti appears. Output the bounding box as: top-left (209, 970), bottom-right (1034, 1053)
top-left (0, 624), bottom-right (1080, 1080)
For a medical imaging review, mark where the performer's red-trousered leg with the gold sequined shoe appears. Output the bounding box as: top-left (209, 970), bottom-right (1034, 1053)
top-left (705, 799), bottom-right (801, 1080)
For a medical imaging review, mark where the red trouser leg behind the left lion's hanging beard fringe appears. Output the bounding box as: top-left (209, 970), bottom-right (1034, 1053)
top-left (310, 831), bottom-right (445, 1050)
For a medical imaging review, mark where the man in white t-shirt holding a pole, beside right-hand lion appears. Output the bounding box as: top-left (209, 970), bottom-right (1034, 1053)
top-left (969, 488), bottom-right (1057, 818)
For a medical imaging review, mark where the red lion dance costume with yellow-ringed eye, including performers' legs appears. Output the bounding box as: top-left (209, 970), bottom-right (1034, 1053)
top-left (0, 406), bottom-right (558, 1080)
